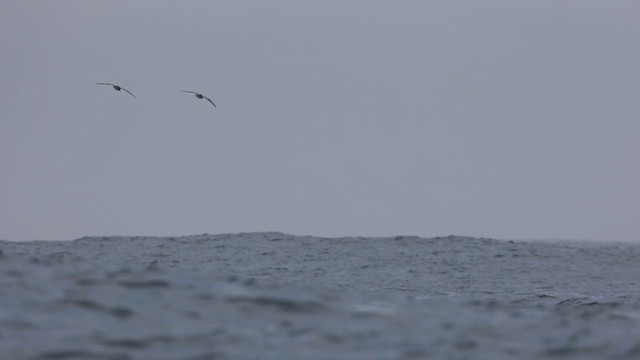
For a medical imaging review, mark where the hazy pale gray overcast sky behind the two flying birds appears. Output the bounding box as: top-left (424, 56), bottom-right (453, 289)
top-left (0, 0), bottom-right (640, 240)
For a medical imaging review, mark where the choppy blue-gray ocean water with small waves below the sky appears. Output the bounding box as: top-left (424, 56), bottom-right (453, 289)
top-left (0, 232), bottom-right (640, 360)
